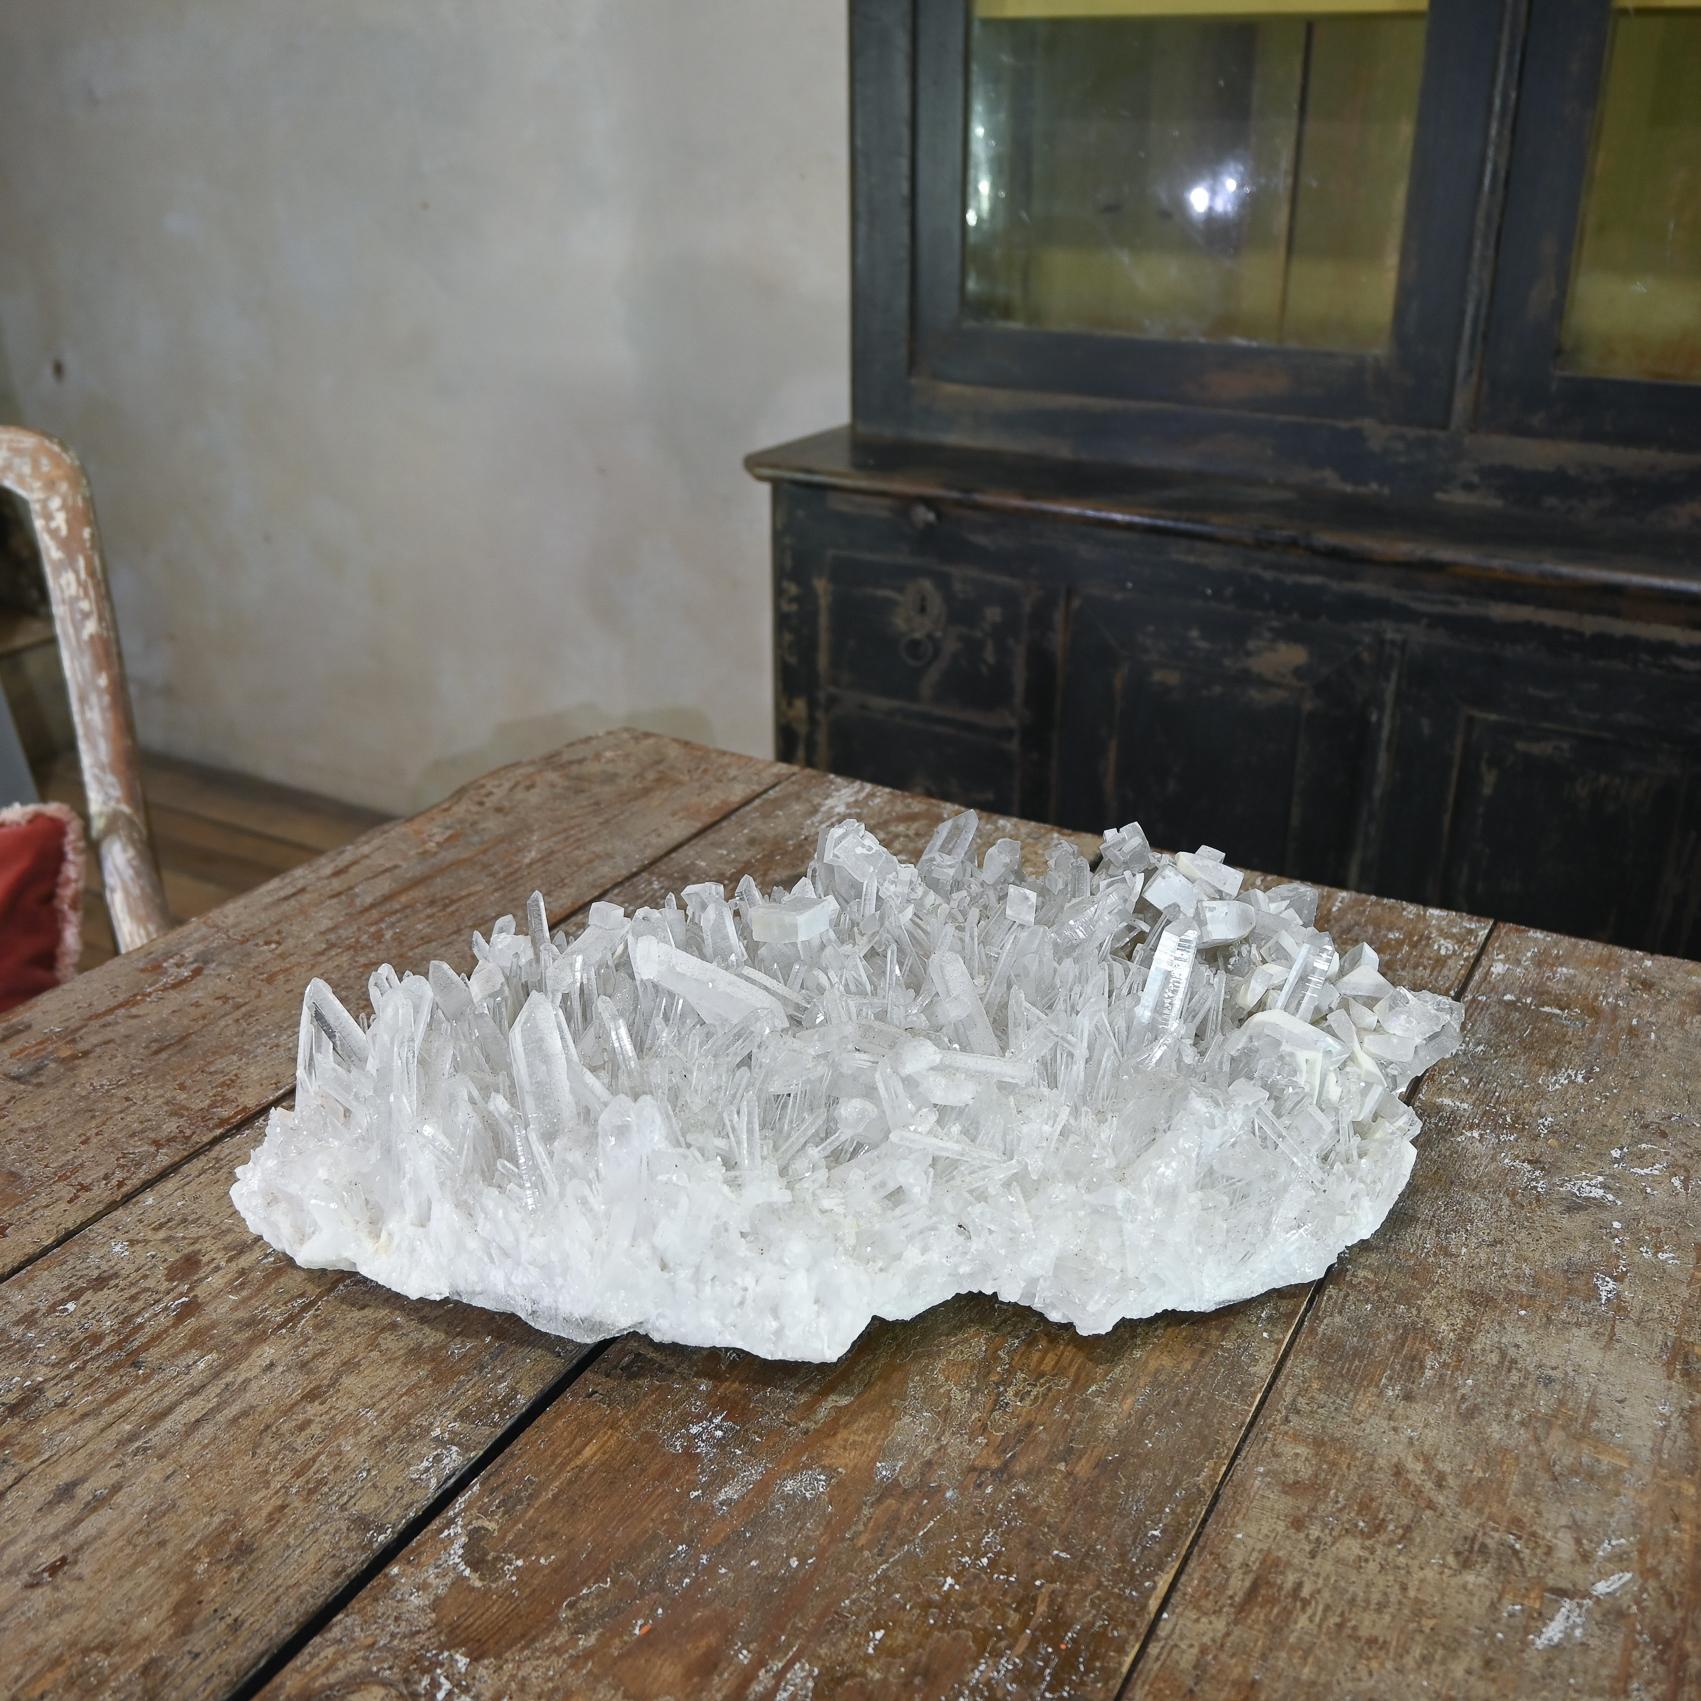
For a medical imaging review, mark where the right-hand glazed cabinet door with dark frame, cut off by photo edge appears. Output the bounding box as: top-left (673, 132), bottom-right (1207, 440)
top-left (1476, 0), bottom-right (1701, 451)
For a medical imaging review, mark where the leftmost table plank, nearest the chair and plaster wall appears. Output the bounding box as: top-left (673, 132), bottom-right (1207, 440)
top-left (0, 731), bottom-right (789, 1274)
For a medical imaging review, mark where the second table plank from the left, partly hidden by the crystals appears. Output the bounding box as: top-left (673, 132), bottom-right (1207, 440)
top-left (0, 772), bottom-right (1081, 1694)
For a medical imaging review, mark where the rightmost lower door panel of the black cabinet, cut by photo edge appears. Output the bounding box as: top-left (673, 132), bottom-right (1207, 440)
top-left (1373, 643), bottom-right (1701, 954)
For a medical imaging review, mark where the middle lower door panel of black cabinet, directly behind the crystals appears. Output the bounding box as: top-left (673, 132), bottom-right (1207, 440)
top-left (1058, 594), bottom-right (1388, 885)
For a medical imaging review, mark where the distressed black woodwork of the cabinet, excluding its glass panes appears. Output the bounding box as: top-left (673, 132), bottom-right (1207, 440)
top-left (752, 0), bottom-right (1701, 954)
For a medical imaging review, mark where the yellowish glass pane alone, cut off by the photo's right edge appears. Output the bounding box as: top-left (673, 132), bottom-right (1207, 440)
top-left (1560, 0), bottom-right (1701, 379)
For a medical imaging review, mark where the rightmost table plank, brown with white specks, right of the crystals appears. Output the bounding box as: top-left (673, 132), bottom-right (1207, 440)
top-left (1129, 929), bottom-right (1701, 1701)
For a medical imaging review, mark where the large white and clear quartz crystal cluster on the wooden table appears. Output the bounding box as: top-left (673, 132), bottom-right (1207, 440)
top-left (231, 815), bottom-right (1459, 1359)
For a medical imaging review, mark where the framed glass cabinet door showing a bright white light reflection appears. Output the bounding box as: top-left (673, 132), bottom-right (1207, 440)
top-left (910, 0), bottom-right (1502, 425)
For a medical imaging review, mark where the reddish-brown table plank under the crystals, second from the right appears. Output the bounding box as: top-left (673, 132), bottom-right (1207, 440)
top-left (255, 896), bottom-right (1487, 1698)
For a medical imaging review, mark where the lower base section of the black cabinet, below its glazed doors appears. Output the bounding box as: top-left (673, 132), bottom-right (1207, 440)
top-left (757, 449), bottom-right (1701, 954)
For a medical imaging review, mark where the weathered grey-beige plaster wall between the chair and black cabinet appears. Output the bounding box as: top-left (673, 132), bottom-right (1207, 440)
top-left (0, 0), bottom-right (849, 808)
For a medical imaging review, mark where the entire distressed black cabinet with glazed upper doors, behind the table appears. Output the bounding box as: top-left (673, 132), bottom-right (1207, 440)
top-left (750, 0), bottom-right (1701, 954)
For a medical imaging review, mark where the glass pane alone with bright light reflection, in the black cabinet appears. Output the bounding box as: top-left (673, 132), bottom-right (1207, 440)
top-left (963, 0), bottom-right (1425, 349)
